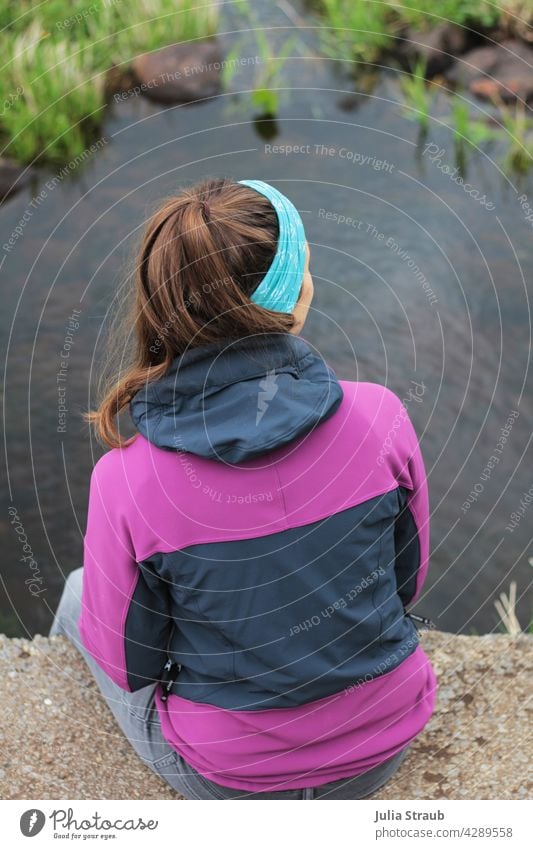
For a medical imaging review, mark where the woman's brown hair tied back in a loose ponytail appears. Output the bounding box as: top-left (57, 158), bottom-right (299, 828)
top-left (85, 179), bottom-right (294, 448)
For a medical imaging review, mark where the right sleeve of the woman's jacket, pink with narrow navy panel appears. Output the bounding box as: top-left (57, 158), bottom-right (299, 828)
top-left (382, 388), bottom-right (430, 607)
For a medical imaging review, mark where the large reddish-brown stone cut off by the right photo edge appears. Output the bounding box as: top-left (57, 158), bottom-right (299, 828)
top-left (446, 39), bottom-right (533, 103)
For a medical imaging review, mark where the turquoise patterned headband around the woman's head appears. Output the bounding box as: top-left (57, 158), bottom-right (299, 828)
top-left (239, 180), bottom-right (306, 313)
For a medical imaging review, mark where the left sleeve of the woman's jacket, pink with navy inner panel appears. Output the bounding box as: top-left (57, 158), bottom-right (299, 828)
top-left (79, 452), bottom-right (172, 692)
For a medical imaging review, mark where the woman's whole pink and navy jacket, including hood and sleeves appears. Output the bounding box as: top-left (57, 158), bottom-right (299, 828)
top-left (80, 334), bottom-right (436, 792)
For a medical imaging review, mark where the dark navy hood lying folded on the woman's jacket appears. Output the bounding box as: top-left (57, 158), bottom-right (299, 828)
top-left (130, 333), bottom-right (343, 463)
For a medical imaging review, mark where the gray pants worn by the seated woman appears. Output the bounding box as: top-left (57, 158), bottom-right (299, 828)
top-left (50, 569), bottom-right (408, 799)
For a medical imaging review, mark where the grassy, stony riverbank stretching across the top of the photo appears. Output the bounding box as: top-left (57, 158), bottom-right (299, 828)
top-left (0, 0), bottom-right (533, 184)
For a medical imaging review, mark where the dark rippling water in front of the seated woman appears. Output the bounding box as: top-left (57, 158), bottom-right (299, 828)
top-left (0, 3), bottom-right (533, 634)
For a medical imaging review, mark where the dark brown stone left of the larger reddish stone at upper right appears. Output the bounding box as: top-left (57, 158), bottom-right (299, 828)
top-left (401, 23), bottom-right (470, 77)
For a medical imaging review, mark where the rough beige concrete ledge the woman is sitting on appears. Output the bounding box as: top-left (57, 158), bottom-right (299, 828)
top-left (0, 632), bottom-right (533, 799)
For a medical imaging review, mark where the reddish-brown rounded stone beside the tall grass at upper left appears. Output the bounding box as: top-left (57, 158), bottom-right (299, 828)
top-left (132, 39), bottom-right (222, 103)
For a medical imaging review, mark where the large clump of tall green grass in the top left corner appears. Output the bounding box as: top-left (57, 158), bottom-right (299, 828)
top-left (0, 0), bottom-right (217, 163)
